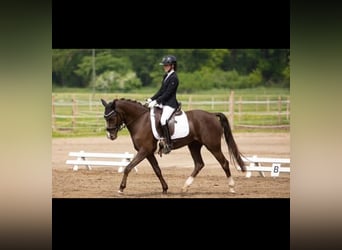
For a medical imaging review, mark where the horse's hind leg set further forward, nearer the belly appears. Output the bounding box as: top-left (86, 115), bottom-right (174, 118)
top-left (182, 142), bottom-right (204, 192)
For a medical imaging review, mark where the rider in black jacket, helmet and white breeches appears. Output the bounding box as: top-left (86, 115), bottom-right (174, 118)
top-left (147, 55), bottom-right (179, 154)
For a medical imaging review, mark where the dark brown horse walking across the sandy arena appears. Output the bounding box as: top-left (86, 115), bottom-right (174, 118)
top-left (101, 98), bottom-right (246, 194)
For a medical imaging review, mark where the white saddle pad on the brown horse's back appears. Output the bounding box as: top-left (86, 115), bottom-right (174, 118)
top-left (150, 108), bottom-right (189, 140)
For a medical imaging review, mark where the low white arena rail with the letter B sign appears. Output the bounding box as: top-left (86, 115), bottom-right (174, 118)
top-left (238, 155), bottom-right (290, 178)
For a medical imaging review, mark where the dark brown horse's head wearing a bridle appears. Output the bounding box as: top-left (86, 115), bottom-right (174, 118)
top-left (101, 99), bottom-right (124, 140)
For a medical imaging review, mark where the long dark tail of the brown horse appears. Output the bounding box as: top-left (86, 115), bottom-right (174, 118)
top-left (216, 113), bottom-right (246, 172)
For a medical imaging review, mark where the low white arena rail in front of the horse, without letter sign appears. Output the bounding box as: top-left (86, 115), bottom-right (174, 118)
top-left (65, 151), bottom-right (138, 173)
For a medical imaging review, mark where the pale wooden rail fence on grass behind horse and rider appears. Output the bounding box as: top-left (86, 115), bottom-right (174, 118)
top-left (52, 91), bottom-right (290, 133)
